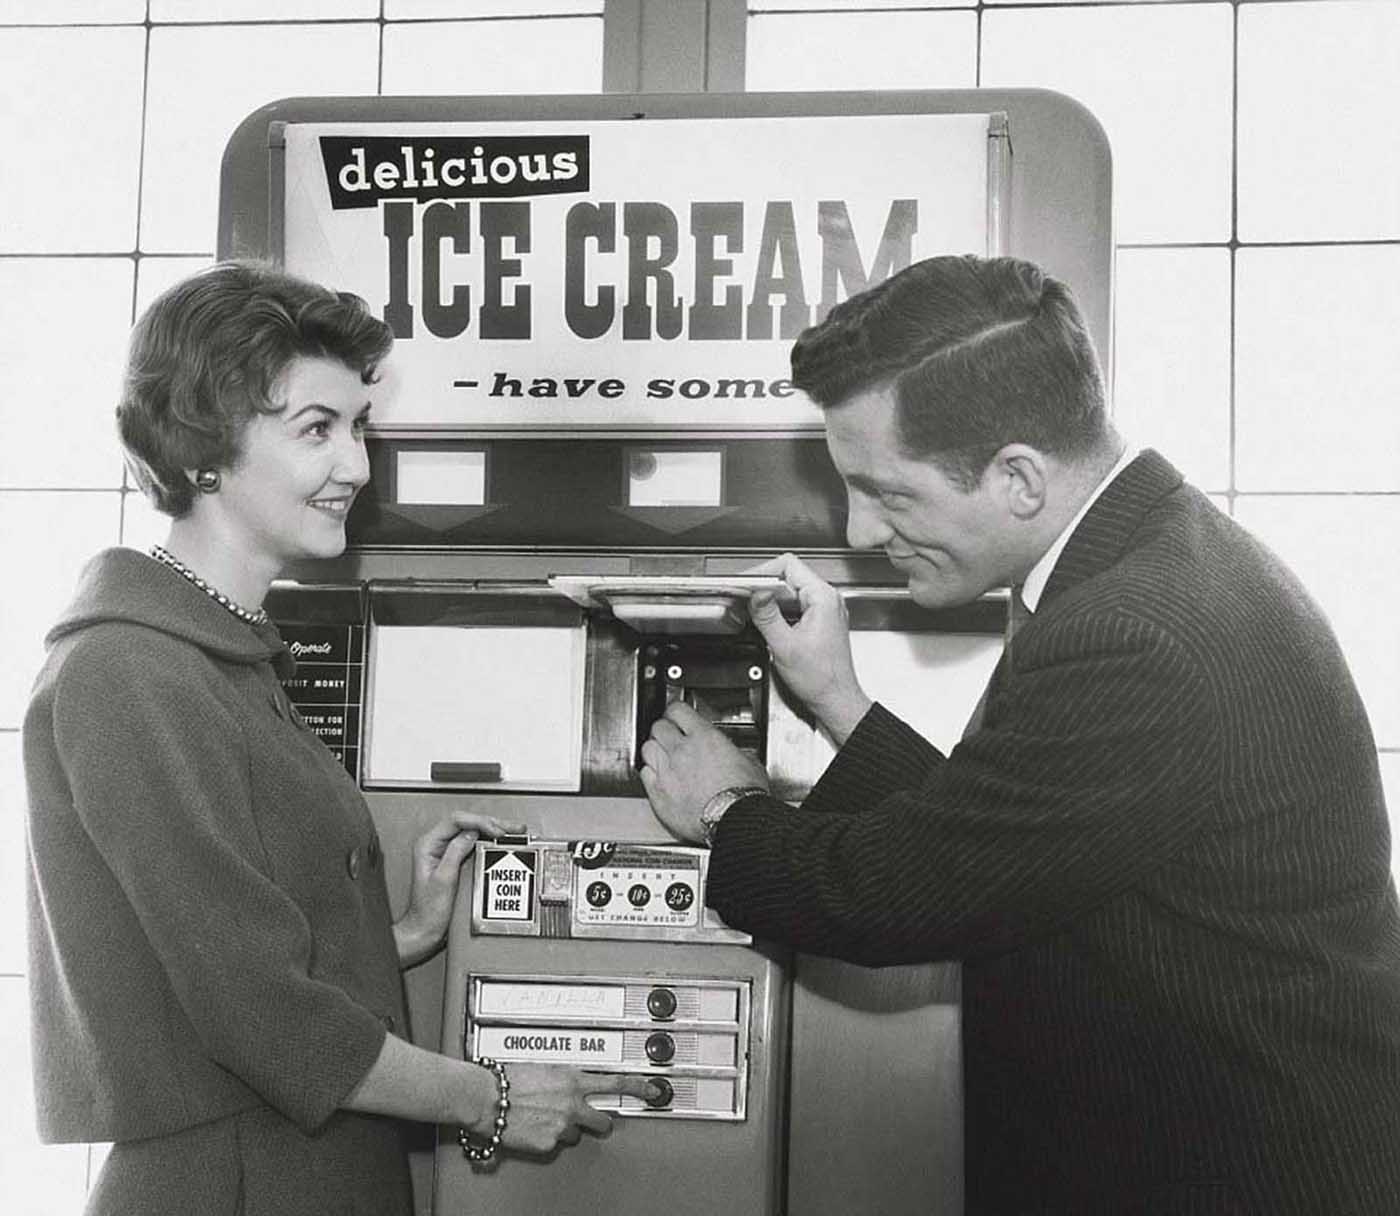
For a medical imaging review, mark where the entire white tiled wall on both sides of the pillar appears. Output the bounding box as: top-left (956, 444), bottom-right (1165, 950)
top-left (0, 0), bottom-right (1400, 1216)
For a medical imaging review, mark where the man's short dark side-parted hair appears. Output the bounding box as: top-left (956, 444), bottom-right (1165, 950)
top-left (792, 255), bottom-right (1109, 490)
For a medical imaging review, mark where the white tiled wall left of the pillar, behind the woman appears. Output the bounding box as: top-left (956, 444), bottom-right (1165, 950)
top-left (0, 0), bottom-right (603, 1216)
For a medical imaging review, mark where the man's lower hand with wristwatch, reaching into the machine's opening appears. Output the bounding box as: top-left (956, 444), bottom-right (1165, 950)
top-left (641, 701), bottom-right (769, 841)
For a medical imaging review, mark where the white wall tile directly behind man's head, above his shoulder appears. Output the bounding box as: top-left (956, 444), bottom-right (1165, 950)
top-left (1113, 249), bottom-right (1231, 490)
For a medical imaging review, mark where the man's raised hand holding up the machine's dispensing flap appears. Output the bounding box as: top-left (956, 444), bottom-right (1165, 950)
top-left (749, 553), bottom-right (872, 747)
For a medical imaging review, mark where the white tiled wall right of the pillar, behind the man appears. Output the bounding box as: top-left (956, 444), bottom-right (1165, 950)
top-left (746, 0), bottom-right (1400, 822)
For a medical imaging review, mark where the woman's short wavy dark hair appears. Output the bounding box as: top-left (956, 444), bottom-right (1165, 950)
top-left (116, 262), bottom-right (393, 519)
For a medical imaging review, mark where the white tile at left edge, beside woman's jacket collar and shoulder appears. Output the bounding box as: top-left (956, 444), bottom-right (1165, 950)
top-left (0, 490), bottom-right (120, 728)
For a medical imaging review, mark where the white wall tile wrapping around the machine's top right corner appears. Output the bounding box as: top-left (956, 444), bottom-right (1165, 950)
top-left (981, 4), bottom-right (1232, 242)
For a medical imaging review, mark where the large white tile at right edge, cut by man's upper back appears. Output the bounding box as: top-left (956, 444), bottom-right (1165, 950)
top-left (1235, 495), bottom-right (1400, 747)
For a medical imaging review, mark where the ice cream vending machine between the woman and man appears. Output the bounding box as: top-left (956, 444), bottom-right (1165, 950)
top-left (220, 91), bottom-right (1112, 1216)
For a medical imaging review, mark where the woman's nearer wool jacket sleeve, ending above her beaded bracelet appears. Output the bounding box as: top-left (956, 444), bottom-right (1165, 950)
top-left (53, 635), bottom-right (385, 1132)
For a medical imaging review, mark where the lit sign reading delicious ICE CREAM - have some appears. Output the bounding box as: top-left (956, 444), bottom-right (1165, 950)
top-left (283, 115), bottom-right (995, 431)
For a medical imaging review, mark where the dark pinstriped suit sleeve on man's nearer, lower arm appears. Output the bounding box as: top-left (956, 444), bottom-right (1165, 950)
top-left (708, 617), bottom-right (1218, 966)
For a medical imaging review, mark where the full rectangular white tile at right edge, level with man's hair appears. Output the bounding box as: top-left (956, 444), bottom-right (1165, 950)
top-left (1235, 246), bottom-right (1400, 491)
